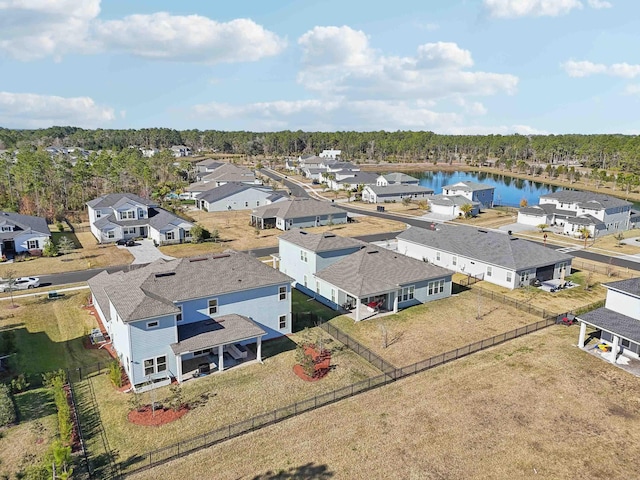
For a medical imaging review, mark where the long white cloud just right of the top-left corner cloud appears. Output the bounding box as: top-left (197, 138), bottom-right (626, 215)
top-left (94, 12), bottom-right (286, 63)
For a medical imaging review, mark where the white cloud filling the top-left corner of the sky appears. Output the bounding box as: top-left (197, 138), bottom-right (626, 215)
top-left (0, 0), bottom-right (100, 61)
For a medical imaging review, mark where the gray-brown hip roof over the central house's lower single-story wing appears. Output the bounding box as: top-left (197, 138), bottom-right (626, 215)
top-left (316, 245), bottom-right (453, 297)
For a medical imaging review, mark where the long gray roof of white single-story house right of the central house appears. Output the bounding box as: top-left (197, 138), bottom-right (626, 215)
top-left (397, 224), bottom-right (573, 271)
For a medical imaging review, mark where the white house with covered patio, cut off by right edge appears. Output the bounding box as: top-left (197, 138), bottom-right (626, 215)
top-left (577, 278), bottom-right (640, 363)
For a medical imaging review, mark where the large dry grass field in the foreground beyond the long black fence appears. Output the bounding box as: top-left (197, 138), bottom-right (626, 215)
top-left (132, 326), bottom-right (640, 480)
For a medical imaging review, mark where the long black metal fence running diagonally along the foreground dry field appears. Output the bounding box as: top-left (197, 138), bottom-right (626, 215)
top-left (119, 314), bottom-right (557, 475)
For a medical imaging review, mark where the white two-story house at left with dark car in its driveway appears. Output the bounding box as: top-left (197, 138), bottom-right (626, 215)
top-left (87, 193), bottom-right (193, 245)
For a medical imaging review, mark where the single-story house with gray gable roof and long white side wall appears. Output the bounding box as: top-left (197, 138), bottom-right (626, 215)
top-left (196, 182), bottom-right (287, 212)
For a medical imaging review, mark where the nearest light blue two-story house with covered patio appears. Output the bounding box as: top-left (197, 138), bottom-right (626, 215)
top-left (88, 251), bottom-right (292, 391)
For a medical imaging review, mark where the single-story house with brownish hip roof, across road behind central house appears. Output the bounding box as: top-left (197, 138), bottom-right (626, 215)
top-left (251, 198), bottom-right (347, 230)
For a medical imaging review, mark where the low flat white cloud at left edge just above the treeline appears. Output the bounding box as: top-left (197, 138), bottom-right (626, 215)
top-left (0, 92), bottom-right (115, 128)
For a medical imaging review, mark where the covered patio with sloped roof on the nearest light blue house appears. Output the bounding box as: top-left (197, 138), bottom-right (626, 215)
top-left (171, 314), bottom-right (267, 383)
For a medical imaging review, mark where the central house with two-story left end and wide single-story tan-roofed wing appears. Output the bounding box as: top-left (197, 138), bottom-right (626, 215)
top-left (279, 229), bottom-right (453, 321)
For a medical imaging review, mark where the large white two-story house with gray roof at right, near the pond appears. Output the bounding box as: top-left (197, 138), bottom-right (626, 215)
top-left (518, 190), bottom-right (632, 237)
